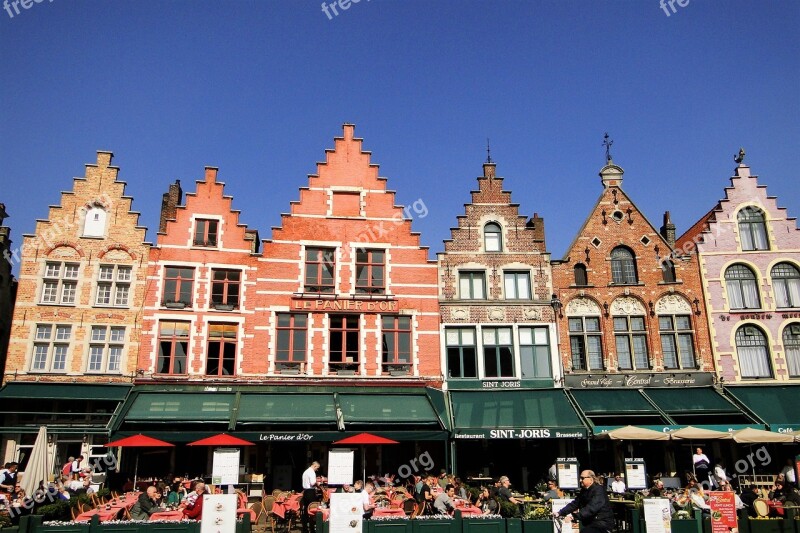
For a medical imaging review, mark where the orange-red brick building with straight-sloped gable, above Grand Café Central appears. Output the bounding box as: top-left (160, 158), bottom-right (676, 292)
top-left (553, 159), bottom-right (752, 471)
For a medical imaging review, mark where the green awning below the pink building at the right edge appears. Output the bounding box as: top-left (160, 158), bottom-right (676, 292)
top-left (725, 385), bottom-right (800, 433)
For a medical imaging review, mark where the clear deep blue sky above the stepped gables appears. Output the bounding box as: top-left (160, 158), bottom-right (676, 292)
top-left (0, 0), bottom-right (800, 274)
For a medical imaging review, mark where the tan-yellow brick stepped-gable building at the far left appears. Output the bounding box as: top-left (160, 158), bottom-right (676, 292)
top-left (2, 152), bottom-right (150, 463)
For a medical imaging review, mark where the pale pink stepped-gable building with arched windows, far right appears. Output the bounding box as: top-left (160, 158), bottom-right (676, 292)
top-left (678, 159), bottom-right (800, 431)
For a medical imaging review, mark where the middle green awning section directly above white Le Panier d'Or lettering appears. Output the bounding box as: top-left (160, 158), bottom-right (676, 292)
top-left (236, 393), bottom-right (336, 425)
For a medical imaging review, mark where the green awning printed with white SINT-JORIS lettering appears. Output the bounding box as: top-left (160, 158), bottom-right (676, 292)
top-left (450, 389), bottom-right (586, 439)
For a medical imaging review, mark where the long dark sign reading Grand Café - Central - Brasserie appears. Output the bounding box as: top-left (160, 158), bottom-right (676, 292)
top-left (564, 372), bottom-right (713, 389)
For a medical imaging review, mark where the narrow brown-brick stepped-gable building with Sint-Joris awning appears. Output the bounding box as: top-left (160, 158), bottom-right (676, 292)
top-left (438, 161), bottom-right (586, 488)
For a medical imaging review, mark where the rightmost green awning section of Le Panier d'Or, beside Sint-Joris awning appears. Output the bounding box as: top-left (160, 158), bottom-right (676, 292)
top-left (337, 394), bottom-right (441, 428)
